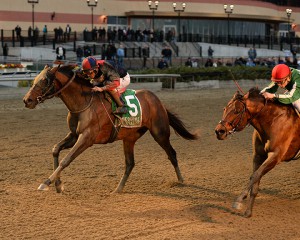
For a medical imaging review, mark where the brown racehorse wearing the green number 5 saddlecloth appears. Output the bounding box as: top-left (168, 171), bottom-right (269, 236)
top-left (23, 65), bottom-right (198, 192)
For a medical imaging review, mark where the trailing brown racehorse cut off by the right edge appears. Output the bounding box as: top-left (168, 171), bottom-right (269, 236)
top-left (215, 88), bottom-right (300, 217)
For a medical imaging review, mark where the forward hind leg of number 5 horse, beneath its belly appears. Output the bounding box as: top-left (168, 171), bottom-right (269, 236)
top-left (114, 140), bottom-right (135, 193)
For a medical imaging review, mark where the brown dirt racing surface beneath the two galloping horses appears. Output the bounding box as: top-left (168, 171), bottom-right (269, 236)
top-left (0, 88), bottom-right (300, 240)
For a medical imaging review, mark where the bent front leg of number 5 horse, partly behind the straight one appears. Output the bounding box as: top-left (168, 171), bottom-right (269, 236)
top-left (52, 132), bottom-right (78, 193)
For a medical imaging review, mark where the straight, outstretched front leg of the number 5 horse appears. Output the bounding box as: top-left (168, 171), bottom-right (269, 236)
top-left (38, 132), bottom-right (93, 190)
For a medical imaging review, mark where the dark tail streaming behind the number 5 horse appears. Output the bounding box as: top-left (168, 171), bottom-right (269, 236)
top-left (167, 109), bottom-right (199, 140)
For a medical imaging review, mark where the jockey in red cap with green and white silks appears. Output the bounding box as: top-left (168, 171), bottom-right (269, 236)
top-left (260, 64), bottom-right (300, 113)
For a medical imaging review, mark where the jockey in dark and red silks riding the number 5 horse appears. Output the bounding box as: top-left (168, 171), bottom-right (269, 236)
top-left (81, 57), bottom-right (130, 114)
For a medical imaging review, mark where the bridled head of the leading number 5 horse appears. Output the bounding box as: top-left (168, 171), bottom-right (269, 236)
top-left (23, 65), bottom-right (75, 109)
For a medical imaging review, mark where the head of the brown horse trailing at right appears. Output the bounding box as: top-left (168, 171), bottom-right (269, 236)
top-left (215, 91), bottom-right (251, 140)
